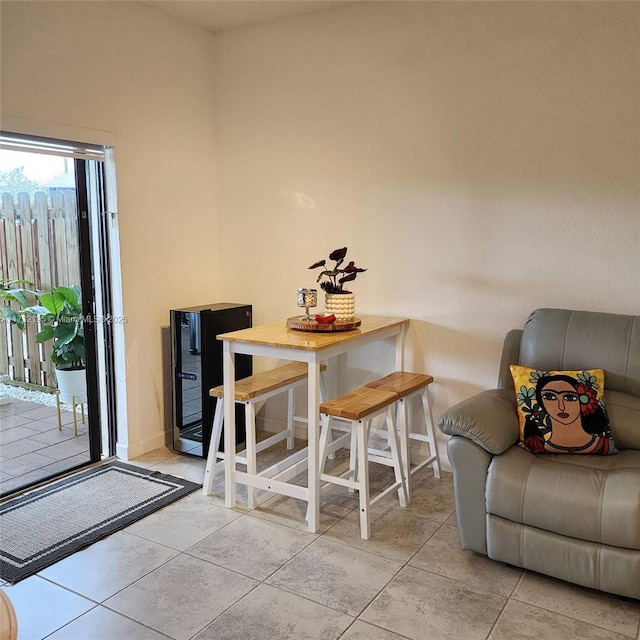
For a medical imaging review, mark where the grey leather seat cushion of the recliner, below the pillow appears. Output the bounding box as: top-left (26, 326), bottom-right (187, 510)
top-left (486, 447), bottom-right (640, 550)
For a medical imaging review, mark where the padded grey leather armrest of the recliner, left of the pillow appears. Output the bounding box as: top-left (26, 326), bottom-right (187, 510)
top-left (438, 389), bottom-right (519, 455)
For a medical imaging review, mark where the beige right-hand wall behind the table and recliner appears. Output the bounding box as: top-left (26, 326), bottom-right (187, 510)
top-left (215, 2), bottom-right (640, 450)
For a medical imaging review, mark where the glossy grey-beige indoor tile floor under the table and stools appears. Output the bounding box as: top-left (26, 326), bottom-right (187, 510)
top-left (3, 449), bottom-right (640, 640)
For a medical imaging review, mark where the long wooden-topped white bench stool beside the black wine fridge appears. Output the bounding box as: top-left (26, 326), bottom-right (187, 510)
top-left (202, 362), bottom-right (326, 509)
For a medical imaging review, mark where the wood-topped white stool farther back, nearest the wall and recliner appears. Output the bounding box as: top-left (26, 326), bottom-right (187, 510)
top-left (365, 371), bottom-right (440, 500)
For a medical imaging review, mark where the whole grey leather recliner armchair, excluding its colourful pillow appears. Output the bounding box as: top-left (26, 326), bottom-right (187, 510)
top-left (438, 309), bottom-right (640, 599)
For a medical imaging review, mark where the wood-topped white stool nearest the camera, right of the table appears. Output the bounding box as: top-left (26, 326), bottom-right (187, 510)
top-left (319, 387), bottom-right (408, 540)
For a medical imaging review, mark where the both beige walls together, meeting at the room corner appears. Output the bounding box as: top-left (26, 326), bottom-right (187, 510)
top-left (0, 2), bottom-right (640, 454)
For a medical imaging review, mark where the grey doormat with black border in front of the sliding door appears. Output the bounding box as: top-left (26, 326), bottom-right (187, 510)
top-left (0, 461), bottom-right (201, 583)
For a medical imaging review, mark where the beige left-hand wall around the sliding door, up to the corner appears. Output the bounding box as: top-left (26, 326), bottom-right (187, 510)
top-left (0, 2), bottom-right (219, 456)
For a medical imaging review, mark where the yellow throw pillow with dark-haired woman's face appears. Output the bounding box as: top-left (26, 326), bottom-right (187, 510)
top-left (510, 365), bottom-right (618, 455)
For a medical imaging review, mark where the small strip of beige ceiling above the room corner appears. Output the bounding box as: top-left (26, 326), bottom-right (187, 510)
top-left (141, 0), bottom-right (354, 33)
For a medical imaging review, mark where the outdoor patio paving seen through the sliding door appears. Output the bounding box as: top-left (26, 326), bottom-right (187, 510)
top-left (0, 399), bottom-right (90, 494)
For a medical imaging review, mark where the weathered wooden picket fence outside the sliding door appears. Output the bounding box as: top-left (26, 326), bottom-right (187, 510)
top-left (0, 189), bottom-right (80, 387)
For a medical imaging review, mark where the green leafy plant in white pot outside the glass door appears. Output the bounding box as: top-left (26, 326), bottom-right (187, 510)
top-left (2, 285), bottom-right (87, 402)
